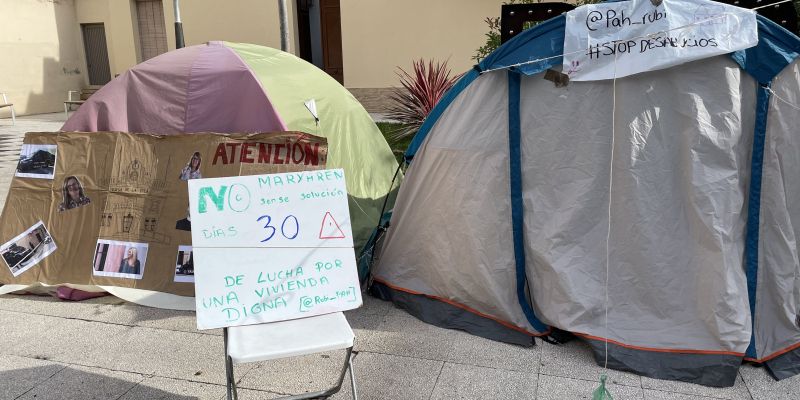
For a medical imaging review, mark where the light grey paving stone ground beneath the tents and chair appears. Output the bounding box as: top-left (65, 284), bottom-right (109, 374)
top-left (0, 114), bottom-right (800, 400)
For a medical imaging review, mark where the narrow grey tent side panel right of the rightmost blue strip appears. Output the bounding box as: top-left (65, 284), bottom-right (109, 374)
top-left (747, 61), bottom-right (800, 379)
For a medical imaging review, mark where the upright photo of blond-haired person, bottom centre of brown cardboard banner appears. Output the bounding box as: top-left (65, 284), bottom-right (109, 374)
top-left (92, 239), bottom-right (148, 279)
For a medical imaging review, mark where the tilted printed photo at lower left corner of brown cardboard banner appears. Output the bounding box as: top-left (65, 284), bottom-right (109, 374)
top-left (0, 221), bottom-right (57, 276)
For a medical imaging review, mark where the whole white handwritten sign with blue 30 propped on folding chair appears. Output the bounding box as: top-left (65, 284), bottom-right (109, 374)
top-left (189, 169), bottom-right (361, 329)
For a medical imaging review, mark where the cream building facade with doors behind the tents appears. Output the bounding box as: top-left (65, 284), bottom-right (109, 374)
top-left (0, 0), bottom-right (520, 117)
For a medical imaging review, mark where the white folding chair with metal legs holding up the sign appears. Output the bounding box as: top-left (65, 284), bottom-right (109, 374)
top-left (223, 312), bottom-right (358, 400)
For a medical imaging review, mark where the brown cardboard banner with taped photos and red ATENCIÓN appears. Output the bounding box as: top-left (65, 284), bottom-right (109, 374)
top-left (0, 132), bottom-right (328, 296)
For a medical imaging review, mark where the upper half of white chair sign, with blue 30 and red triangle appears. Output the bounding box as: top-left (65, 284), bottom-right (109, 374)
top-left (189, 169), bottom-right (353, 248)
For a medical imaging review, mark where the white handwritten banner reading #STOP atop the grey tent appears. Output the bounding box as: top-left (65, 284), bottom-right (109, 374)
top-left (564, 0), bottom-right (758, 81)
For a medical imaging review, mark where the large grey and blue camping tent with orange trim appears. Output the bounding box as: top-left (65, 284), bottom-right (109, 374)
top-left (372, 10), bottom-right (800, 386)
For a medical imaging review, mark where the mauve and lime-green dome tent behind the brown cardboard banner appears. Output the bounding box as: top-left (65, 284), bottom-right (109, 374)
top-left (61, 42), bottom-right (399, 250)
